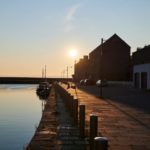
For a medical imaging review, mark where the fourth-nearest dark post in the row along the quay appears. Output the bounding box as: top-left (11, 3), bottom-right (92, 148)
top-left (73, 99), bottom-right (78, 124)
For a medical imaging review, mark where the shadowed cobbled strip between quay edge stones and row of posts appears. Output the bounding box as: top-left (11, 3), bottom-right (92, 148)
top-left (57, 96), bottom-right (88, 150)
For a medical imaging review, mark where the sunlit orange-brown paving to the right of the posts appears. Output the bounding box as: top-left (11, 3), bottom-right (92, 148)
top-left (63, 85), bottom-right (150, 150)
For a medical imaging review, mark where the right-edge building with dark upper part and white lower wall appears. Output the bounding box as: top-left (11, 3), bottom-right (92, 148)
top-left (132, 45), bottom-right (150, 89)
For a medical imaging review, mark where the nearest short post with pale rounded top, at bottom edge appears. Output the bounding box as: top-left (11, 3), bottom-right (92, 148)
top-left (94, 137), bottom-right (108, 150)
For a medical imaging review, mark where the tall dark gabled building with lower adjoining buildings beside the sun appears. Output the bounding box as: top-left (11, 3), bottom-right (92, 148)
top-left (75, 34), bottom-right (130, 81)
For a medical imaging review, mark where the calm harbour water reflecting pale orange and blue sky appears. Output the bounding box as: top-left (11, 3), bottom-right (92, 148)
top-left (0, 85), bottom-right (42, 150)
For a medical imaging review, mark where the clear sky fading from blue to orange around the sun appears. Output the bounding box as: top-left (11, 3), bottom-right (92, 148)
top-left (0, 0), bottom-right (150, 77)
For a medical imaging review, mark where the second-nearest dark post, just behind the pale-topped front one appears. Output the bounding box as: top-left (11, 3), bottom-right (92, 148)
top-left (90, 114), bottom-right (98, 150)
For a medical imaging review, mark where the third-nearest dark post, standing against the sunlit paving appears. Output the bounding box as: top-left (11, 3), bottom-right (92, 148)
top-left (79, 105), bottom-right (85, 138)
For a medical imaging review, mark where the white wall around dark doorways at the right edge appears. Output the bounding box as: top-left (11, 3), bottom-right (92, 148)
top-left (133, 63), bottom-right (150, 89)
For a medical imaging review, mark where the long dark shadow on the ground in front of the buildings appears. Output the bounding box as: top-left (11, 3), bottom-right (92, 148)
top-left (78, 85), bottom-right (150, 113)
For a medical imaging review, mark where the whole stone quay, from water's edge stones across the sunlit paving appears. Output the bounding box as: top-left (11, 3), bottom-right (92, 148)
top-left (27, 83), bottom-right (150, 150)
